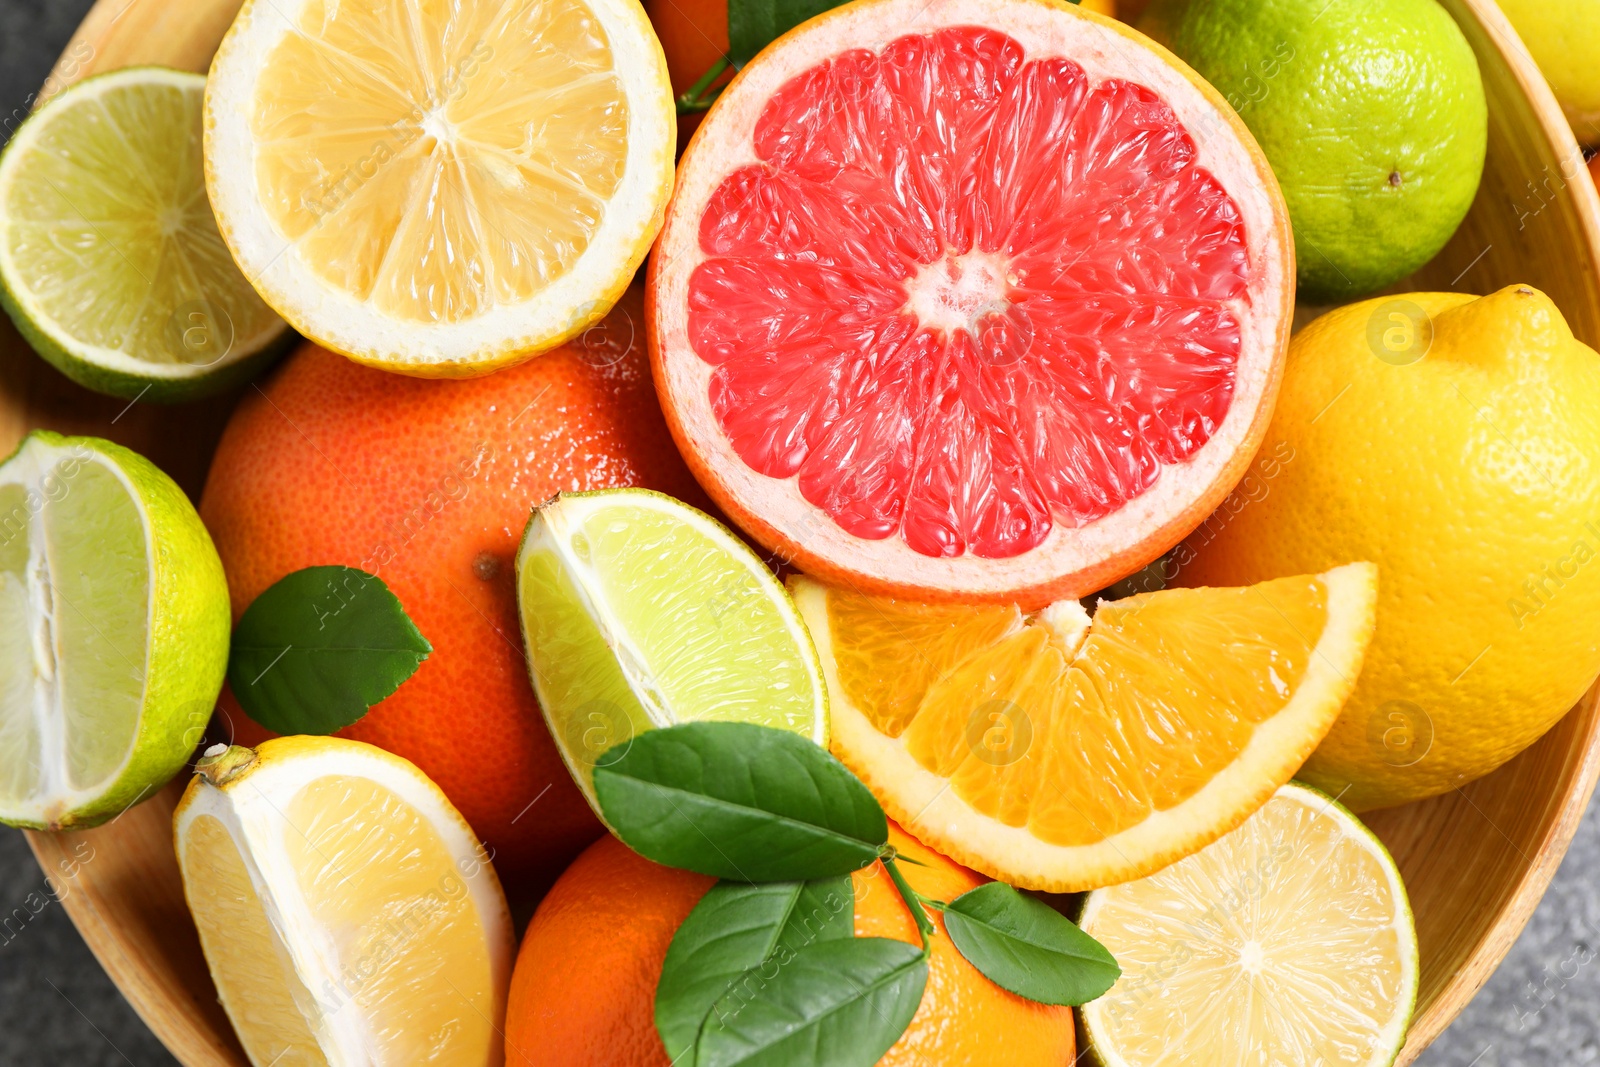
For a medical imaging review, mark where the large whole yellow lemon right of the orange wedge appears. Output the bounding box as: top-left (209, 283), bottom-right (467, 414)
top-left (1168, 285), bottom-right (1600, 811)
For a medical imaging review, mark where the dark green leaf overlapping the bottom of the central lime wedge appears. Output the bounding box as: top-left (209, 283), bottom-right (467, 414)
top-left (594, 723), bottom-right (890, 881)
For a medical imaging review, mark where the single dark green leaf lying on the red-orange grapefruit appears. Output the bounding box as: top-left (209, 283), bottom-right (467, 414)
top-left (227, 566), bottom-right (434, 734)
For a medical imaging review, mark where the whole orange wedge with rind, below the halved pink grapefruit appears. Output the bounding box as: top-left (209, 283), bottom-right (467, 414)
top-left (792, 563), bottom-right (1378, 893)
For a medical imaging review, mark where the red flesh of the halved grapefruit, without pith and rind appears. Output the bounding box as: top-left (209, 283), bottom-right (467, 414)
top-left (675, 26), bottom-right (1251, 558)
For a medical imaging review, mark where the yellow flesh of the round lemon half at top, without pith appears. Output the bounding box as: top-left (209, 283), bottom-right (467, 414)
top-left (250, 0), bottom-right (627, 322)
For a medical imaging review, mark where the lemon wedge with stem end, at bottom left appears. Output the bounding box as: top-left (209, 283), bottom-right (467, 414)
top-left (173, 737), bottom-right (514, 1067)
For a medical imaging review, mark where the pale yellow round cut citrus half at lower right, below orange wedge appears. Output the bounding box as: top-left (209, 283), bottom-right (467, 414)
top-left (1080, 782), bottom-right (1418, 1067)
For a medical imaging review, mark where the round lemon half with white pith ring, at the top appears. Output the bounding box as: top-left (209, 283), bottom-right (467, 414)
top-left (205, 0), bottom-right (677, 376)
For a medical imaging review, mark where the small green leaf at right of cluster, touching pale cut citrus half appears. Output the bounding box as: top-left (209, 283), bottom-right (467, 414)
top-left (944, 881), bottom-right (1122, 1006)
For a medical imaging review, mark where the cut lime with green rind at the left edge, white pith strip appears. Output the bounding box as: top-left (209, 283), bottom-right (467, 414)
top-left (0, 430), bottom-right (229, 830)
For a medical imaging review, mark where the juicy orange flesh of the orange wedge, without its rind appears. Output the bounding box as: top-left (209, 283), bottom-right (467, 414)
top-left (827, 577), bottom-right (1328, 845)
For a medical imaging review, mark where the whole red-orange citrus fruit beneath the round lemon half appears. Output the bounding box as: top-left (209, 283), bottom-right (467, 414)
top-left (200, 290), bottom-right (704, 899)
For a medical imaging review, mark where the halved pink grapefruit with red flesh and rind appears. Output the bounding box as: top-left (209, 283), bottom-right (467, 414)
top-left (648, 0), bottom-right (1294, 606)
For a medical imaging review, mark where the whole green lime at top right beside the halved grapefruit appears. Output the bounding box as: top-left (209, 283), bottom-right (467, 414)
top-left (1139, 0), bottom-right (1488, 304)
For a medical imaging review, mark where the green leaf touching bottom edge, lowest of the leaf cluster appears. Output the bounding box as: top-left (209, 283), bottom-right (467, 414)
top-left (693, 937), bottom-right (928, 1067)
